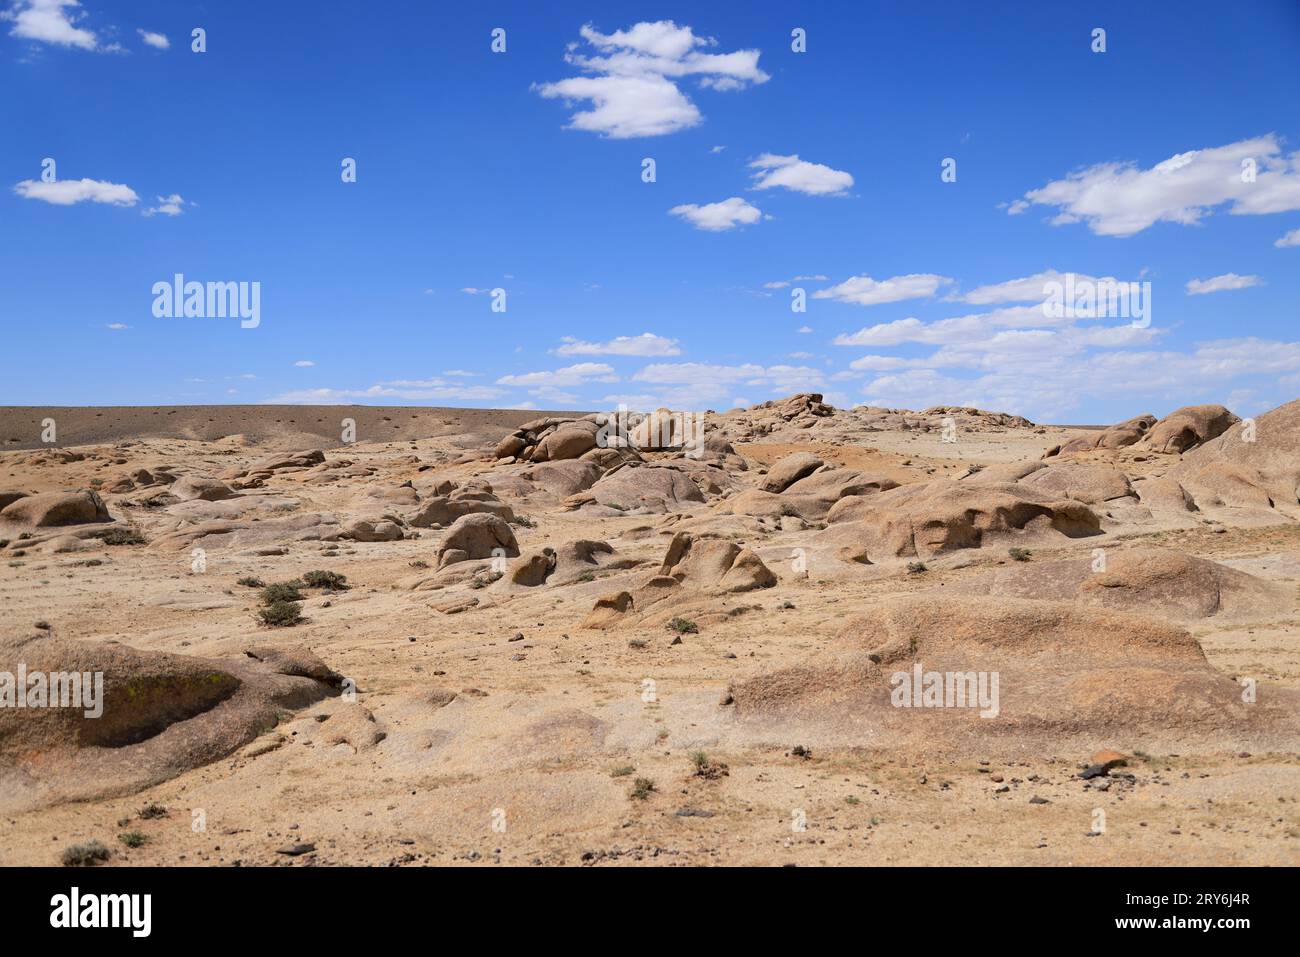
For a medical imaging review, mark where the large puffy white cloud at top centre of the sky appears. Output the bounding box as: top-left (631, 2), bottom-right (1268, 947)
top-left (533, 20), bottom-right (768, 139)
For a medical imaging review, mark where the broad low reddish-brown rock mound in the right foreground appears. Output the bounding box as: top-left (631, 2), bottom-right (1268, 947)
top-left (724, 592), bottom-right (1297, 758)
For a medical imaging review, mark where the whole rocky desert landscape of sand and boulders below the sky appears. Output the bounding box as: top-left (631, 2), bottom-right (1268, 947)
top-left (0, 393), bottom-right (1300, 867)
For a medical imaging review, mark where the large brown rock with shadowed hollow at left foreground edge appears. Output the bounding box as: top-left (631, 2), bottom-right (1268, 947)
top-left (0, 636), bottom-right (339, 814)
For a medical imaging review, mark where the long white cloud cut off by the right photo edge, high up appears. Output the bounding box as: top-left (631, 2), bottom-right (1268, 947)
top-left (1008, 134), bottom-right (1300, 237)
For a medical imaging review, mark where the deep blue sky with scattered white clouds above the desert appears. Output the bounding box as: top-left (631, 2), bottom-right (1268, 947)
top-left (0, 0), bottom-right (1300, 421)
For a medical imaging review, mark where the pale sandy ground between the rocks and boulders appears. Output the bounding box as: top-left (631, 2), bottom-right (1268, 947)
top-left (0, 407), bottom-right (1300, 866)
